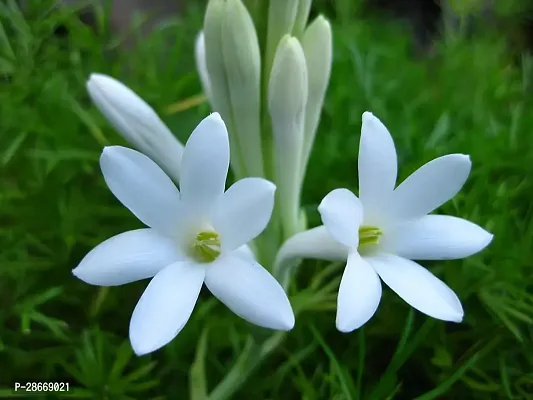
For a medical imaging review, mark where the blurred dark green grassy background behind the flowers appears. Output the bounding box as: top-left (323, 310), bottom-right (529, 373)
top-left (0, 0), bottom-right (533, 400)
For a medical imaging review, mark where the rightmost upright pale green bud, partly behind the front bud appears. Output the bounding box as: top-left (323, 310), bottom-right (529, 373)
top-left (301, 16), bottom-right (333, 181)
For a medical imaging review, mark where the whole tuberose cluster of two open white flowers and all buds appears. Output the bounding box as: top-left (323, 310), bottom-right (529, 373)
top-left (73, 0), bottom-right (492, 360)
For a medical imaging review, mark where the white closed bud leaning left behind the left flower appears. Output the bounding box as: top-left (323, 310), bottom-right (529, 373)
top-left (87, 74), bottom-right (183, 183)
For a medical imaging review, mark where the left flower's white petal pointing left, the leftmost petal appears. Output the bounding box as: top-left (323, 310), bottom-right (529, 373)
top-left (72, 229), bottom-right (183, 286)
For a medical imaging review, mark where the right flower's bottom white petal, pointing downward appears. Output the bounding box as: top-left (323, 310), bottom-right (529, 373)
top-left (336, 251), bottom-right (381, 332)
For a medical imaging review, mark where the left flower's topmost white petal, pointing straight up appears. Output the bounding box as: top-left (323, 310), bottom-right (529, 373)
top-left (180, 113), bottom-right (229, 214)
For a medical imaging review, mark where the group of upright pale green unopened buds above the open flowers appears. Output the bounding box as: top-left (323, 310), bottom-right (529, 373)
top-left (195, 0), bottom-right (332, 241)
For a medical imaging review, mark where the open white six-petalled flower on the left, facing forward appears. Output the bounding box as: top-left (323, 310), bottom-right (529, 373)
top-left (73, 113), bottom-right (294, 355)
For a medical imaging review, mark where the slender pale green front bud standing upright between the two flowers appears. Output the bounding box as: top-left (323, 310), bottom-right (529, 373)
top-left (268, 35), bottom-right (308, 237)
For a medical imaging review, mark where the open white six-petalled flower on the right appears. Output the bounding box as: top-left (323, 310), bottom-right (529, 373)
top-left (312, 112), bottom-right (492, 332)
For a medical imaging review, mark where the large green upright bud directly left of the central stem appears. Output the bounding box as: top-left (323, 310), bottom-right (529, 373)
top-left (221, 0), bottom-right (264, 177)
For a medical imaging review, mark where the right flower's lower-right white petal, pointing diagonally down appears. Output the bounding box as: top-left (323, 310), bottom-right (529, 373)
top-left (366, 254), bottom-right (464, 322)
